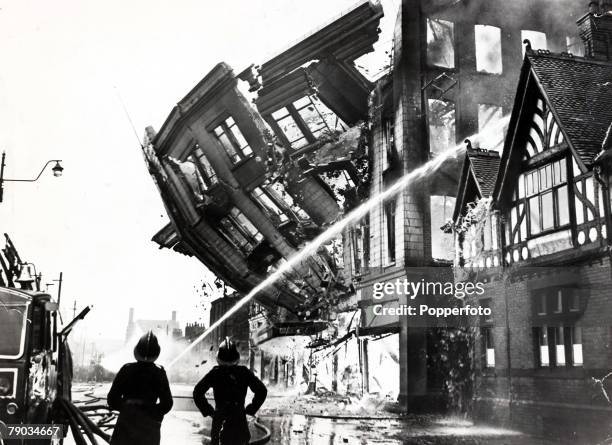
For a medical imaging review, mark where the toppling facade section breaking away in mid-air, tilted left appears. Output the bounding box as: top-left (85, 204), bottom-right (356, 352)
top-left (145, 1), bottom-right (382, 386)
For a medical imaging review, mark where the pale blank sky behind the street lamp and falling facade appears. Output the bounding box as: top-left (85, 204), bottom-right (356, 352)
top-left (0, 0), bottom-right (400, 339)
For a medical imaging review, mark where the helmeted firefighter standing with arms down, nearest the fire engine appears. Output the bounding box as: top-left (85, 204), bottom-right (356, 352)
top-left (107, 331), bottom-right (172, 445)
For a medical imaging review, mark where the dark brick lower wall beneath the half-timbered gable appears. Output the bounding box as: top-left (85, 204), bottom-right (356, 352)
top-left (474, 257), bottom-right (612, 443)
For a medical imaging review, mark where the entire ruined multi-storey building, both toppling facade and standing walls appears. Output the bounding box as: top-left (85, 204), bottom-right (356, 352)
top-left (140, 0), bottom-right (596, 424)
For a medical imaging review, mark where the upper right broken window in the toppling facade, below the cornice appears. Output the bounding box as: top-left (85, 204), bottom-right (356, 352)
top-left (272, 95), bottom-right (348, 149)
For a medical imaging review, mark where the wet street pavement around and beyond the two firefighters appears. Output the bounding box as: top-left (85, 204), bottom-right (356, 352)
top-left (65, 385), bottom-right (553, 445)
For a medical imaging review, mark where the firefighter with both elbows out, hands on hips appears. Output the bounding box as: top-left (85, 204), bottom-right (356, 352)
top-left (193, 337), bottom-right (268, 445)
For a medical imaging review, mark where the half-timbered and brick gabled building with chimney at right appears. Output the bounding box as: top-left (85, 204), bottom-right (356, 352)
top-left (454, 2), bottom-right (612, 443)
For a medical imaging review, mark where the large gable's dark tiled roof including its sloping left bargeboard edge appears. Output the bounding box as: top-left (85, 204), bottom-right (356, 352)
top-left (493, 50), bottom-right (612, 200)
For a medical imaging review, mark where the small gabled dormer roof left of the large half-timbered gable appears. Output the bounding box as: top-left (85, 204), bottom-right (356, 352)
top-left (453, 148), bottom-right (500, 220)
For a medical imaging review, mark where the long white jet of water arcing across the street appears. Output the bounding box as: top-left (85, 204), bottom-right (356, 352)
top-left (168, 116), bottom-right (509, 368)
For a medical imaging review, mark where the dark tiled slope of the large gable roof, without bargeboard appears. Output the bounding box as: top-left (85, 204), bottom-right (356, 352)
top-left (527, 52), bottom-right (612, 165)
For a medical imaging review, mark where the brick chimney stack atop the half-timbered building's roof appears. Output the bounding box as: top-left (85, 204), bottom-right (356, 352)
top-left (576, 0), bottom-right (612, 60)
